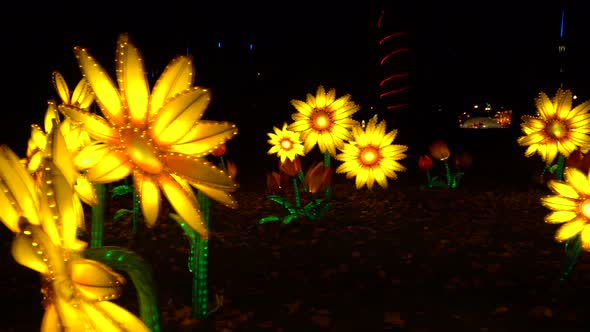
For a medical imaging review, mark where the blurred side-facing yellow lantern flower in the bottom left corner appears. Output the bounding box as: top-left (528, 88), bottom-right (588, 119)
top-left (0, 145), bottom-right (148, 331)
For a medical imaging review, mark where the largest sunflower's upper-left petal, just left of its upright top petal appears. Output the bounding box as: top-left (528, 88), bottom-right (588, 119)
top-left (74, 47), bottom-right (127, 126)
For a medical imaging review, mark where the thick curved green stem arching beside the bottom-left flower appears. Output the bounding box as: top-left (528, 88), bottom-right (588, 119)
top-left (83, 246), bottom-right (160, 332)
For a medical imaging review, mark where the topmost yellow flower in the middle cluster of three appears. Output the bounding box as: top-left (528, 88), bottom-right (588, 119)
top-left (287, 85), bottom-right (360, 156)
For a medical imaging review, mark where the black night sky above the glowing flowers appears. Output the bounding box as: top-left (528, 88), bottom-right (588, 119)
top-left (0, 0), bottom-right (590, 178)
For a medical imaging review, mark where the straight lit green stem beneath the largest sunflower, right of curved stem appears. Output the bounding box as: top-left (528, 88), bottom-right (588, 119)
top-left (191, 191), bottom-right (211, 319)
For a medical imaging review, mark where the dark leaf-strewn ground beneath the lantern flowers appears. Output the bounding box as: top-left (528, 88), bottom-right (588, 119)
top-left (0, 131), bottom-right (590, 332)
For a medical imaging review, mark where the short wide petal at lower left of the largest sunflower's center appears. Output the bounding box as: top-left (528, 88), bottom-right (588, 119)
top-left (86, 151), bottom-right (134, 183)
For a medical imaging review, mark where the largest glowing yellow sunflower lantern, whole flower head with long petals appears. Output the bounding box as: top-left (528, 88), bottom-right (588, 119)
top-left (59, 34), bottom-right (237, 239)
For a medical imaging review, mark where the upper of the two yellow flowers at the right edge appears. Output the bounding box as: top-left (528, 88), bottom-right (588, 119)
top-left (517, 88), bottom-right (590, 165)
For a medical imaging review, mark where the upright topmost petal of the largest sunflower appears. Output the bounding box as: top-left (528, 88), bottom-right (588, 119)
top-left (116, 34), bottom-right (149, 128)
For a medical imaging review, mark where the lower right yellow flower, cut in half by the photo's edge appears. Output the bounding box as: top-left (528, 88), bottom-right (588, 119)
top-left (541, 167), bottom-right (590, 251)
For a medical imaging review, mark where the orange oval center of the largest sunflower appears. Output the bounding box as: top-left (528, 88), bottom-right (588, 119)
top-left (122, 129), bottom-right (163, 174)
